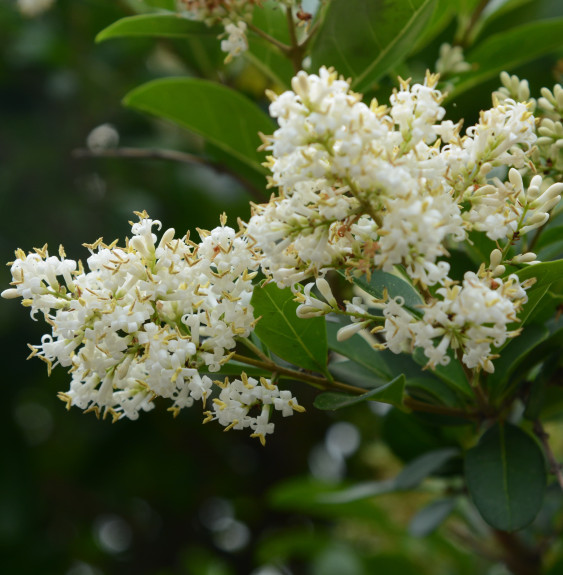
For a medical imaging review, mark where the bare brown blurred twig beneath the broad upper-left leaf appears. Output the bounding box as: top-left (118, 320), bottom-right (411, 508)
top-left (72, 148), bottom-right (265, 203)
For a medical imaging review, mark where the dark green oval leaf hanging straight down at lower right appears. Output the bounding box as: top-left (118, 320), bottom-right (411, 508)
top-left (465, 423), bottom-right (546, 531)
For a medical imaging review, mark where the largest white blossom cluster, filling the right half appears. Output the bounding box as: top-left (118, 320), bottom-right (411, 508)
top-left (256, 68), bottom-right (563, 372)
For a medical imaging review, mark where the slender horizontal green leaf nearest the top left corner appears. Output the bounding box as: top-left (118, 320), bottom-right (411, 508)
top-left (96, 14), bottom-right (217, 42)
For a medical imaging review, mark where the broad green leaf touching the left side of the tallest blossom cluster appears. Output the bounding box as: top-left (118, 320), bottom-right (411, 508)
top-left (124, 78), bottom-right (275, 174)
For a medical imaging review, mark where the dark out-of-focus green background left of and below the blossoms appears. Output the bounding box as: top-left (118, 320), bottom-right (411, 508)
top-left (0, 0), bottom-right (561, 575)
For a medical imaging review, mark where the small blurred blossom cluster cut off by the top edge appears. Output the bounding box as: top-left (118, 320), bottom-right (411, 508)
top-left (178, 0), bottom-right (258, 62)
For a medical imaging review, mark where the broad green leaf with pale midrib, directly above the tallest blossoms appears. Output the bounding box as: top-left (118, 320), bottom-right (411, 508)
top-left (311, 0), bottom-right (436, 91)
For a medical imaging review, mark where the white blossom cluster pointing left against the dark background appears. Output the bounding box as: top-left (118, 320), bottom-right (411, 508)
top-left (2, 213), bottom-right (304, 439)
